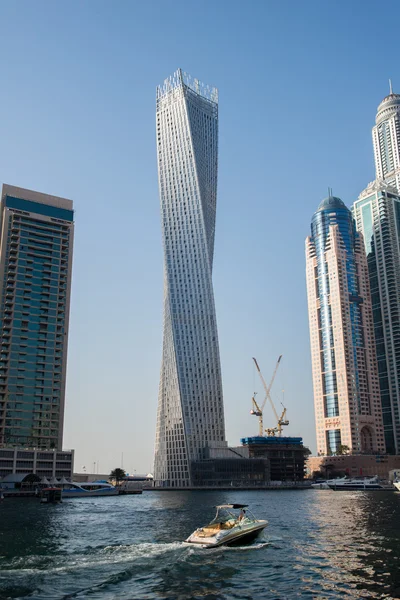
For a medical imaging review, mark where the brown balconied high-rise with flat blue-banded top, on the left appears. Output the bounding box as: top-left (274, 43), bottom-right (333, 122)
top-left (0, 185), bottom-right (74, 449)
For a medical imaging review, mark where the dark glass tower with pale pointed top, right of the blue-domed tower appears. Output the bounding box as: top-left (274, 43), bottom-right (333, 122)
top-left (353, 179), bottom-right (400, 454)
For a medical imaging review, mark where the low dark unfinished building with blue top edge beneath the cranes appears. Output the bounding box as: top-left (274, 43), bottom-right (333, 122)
top-left (240, 436), bottom-right (310, 481)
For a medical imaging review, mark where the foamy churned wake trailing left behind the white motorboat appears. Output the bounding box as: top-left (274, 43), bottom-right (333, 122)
top-left (0, 540), bottom-right (270, 600)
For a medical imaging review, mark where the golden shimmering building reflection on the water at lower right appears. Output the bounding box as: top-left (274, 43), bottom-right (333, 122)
top-left (299, 491), bottom-right (400, 598)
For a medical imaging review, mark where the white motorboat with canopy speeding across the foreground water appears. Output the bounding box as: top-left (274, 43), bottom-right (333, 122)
top-left (185, 504), bottom-right (268, 548)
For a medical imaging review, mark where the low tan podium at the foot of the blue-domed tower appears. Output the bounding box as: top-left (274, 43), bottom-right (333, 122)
top-left (306, 454), bottom-right (400, 479)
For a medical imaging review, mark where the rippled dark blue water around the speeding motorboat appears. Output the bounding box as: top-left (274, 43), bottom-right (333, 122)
top-left (0, 490), bottom-right (400, 600)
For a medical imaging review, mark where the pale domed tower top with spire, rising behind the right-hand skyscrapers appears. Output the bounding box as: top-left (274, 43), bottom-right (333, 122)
top-left (372, 84), bottom-right (400, 192)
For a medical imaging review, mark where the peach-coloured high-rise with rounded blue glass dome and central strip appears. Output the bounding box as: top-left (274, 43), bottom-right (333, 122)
top-left (306, 196), bottom-right (385, 455)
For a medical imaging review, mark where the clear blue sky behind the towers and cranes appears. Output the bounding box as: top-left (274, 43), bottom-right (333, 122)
top-left (0, 0), bottom-right (400, 473)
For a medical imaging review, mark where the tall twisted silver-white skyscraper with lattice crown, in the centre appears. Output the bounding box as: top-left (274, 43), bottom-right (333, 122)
top-left (154, 70), bottom-right (226, 487)
